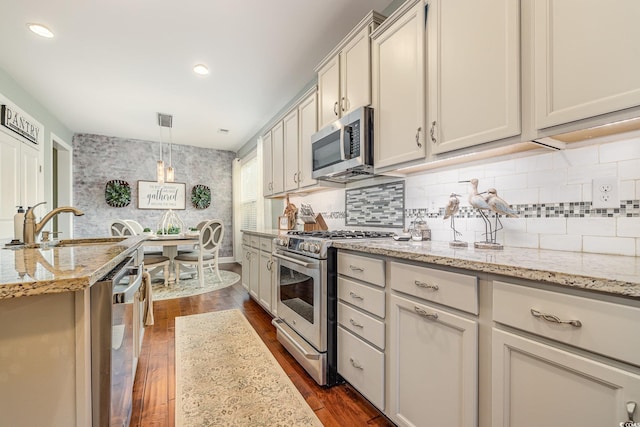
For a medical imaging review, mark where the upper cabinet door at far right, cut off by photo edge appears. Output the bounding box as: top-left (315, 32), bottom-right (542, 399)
top-left (534, 0), bottom-right (640, 129)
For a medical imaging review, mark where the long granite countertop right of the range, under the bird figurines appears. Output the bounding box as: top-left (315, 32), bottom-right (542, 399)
top-left (333, 239), bottom-right (640, 298)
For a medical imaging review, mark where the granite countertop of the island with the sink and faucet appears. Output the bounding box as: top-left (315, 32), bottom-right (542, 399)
top-left (0, 236), bottom-right (147, 299)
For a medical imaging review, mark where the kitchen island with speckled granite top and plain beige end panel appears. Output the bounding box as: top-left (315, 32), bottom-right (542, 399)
top-left (0, 236), bottom-right (145, 427)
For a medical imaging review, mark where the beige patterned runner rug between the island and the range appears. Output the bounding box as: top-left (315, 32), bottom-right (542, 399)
top-left (175, 309), bottom-right (322, 427)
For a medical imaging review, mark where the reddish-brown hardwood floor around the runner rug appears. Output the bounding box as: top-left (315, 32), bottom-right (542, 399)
top-left (131, 264), bottom-right (393, 427)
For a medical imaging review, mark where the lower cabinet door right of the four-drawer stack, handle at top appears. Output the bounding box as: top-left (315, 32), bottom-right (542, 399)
top-left (389, 295), bottom-right (478, 427)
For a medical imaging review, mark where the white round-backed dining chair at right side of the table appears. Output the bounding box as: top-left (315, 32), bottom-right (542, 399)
top-left (173, 219), bottom-right (224, 287)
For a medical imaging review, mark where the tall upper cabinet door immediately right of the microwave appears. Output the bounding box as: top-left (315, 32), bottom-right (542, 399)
top-left (372, 2), bottom-right (426, 168)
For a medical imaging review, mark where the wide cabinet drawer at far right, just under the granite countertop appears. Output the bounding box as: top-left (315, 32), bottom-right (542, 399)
top-left (493, 281), bottom-right (640, 366)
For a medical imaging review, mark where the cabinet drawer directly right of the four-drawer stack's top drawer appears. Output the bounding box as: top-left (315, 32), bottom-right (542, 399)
top-left (389, 262), bottom-right (478, 314)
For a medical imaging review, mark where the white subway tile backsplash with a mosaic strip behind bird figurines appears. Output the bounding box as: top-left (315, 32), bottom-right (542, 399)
top-left (292, 135), bottom-right (640, 256)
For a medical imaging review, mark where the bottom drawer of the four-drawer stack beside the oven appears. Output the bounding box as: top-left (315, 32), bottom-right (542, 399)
top-left (338, 327), bottom-right (384, 410)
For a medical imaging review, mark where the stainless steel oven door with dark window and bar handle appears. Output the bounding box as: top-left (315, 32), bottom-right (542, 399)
top-left (273, 251), bottom-right (327, 352)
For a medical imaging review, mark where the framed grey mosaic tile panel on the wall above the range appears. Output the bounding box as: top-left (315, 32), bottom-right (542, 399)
top-left (345, 181), bottom-right (404, 228)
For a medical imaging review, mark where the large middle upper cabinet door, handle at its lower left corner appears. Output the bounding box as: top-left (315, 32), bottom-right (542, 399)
top-left (427, 0), bottom-right (520, 153)
